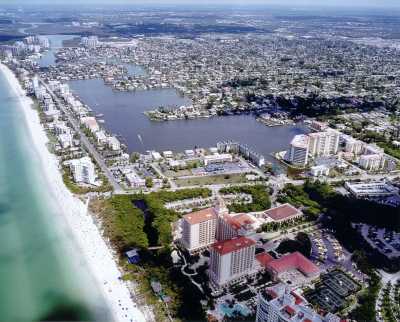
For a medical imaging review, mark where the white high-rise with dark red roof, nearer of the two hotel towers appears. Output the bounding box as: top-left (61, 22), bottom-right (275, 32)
top-left (209, 236), bottom-right (256, 287)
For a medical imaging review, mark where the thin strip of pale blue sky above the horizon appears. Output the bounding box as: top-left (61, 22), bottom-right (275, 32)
top-left (0, 0), bottom-right (400, 7)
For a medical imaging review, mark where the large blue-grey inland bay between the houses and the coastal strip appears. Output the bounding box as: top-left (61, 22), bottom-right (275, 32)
top-left (69, 79), bottom-right (307, 161)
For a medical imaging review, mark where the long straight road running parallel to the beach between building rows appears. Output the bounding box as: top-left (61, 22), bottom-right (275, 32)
top-left (39, 78), bottom-right (124, 194)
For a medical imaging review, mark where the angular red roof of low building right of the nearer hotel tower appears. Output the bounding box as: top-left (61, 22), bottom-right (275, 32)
top-left (267, 252), bottom-right (319, 275)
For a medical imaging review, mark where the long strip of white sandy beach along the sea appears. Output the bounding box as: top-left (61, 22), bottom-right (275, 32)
top-left (0, 64), bottom-right (146, 322)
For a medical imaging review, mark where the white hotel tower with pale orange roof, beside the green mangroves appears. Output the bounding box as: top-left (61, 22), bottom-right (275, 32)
top-left (181, 208), bottom-right (218, 253)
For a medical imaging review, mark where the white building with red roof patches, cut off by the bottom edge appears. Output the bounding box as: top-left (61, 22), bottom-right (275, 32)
top-left (256, 283), bottom-right (341, 322)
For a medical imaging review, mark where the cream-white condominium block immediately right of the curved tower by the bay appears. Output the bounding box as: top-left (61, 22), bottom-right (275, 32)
top-left (308, 129), bottom-right (340, 157)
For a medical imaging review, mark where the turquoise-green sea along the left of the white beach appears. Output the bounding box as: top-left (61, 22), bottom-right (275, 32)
top-left (0, 68), bottom-right (109, 321)
